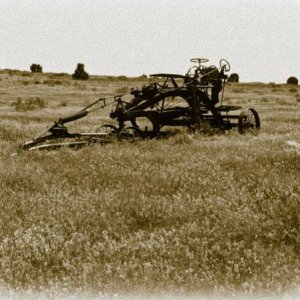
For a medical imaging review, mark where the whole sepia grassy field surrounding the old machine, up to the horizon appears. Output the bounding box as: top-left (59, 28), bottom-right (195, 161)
top-left (0, 70), bottom-right (300, 294)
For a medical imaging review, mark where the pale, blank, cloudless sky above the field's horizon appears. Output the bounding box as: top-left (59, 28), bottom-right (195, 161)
top-left (0, 0), bottom-right (300, 83)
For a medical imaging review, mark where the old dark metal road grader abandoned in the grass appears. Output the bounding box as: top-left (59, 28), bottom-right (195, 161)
top-left (21, 58), bottom-right (260, 150)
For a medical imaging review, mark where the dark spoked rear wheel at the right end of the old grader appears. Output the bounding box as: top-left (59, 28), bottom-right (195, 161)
top-left (238, 108), bottom-right (260, 134)
